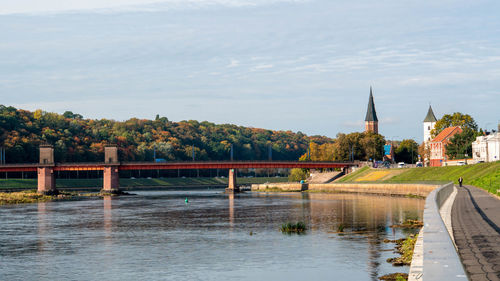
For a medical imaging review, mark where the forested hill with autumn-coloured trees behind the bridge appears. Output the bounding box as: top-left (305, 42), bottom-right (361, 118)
top-left (0, 105), bottom-right (333, 163)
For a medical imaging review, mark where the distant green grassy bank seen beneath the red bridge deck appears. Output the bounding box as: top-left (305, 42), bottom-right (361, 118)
top-left (0, 177), bottom-right (288, 190)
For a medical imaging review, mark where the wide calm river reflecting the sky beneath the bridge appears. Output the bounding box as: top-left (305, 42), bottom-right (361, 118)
top-left (0, 189), bottom-right (424, 281)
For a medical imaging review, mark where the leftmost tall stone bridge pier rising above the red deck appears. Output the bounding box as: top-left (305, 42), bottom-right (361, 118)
top-left (37, 145), bottom-right (59, 195)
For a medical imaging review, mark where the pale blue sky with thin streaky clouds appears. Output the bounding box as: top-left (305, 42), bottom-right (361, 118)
top-left (0, 0), bottom-right (500, 142)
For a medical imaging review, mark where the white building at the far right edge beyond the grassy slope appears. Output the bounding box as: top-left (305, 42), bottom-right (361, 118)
top-left (472, 132), bottom-right (500, 162)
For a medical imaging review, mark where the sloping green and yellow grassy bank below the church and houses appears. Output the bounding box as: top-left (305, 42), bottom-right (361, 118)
top-left (337, 161), bottom-right (500, 194)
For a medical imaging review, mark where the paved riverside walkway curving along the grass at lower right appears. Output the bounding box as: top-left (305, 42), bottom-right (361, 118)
top-left (452, 186), bottom-right (500, 281)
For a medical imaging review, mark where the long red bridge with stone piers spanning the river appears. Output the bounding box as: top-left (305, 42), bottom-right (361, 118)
top-left (0, 145), bottom-right (356, 194)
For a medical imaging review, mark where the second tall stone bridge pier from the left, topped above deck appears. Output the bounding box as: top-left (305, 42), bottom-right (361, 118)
top-left (102, 146), bottom-right (120, 193)
